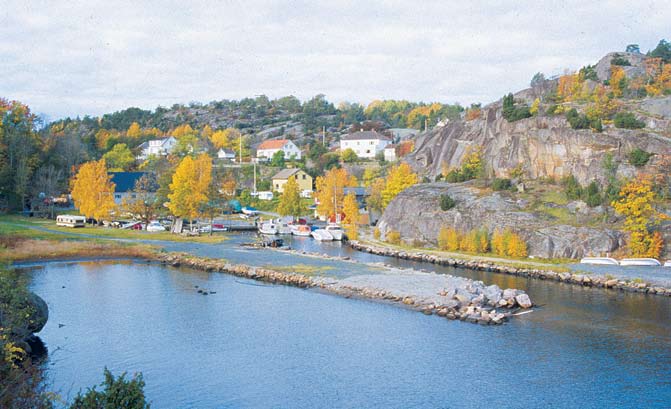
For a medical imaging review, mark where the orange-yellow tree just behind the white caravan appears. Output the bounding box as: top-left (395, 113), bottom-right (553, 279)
top-left (71, 159), bottom-right (116, 221)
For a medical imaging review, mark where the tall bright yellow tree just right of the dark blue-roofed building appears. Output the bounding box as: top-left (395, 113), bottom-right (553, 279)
top-left (168, 154), bottom-right (212, 219)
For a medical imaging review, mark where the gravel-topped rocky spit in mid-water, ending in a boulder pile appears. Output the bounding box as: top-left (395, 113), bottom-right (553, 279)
top-left (157, 253), bottom-right (533, 325)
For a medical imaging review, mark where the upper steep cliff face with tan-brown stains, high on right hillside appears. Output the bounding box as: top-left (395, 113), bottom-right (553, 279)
top-left (405, 101), bottom-right (671, 184)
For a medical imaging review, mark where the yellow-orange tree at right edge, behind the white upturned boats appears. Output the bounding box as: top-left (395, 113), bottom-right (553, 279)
top-left (611, 178), bottom-right (668, 257)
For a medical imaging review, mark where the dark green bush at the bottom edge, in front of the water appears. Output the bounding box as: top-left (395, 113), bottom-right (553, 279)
top-left (70, 368), bottom-right (149, 409)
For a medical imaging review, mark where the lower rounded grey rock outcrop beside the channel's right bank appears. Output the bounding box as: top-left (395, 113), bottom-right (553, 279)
top-left (378, 182), bottom-right (624, 258)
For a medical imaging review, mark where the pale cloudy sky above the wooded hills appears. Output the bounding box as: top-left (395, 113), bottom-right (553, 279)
top-left (0, 0), bottom-right (671, 120)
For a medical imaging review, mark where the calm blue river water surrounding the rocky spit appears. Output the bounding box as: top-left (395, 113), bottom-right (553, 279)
top-left (25, 235), bottom-right (671, 408)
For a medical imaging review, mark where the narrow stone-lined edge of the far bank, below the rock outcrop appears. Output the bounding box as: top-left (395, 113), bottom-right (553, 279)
top-left (349, 241), bottom-right (671, 297)
